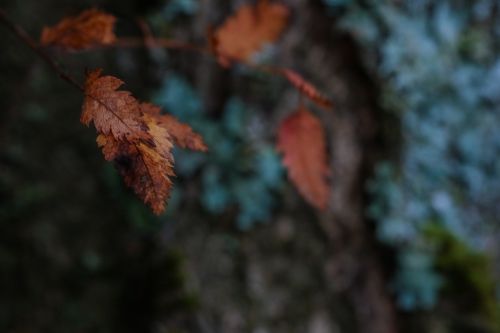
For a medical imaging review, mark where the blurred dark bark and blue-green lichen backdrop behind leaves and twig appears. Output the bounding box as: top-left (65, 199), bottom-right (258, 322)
top-left (0, 0), bottom-right (500, 333)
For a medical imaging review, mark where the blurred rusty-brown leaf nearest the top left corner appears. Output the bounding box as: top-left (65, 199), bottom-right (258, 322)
top-left (40, 8), bottom-right (116, 50)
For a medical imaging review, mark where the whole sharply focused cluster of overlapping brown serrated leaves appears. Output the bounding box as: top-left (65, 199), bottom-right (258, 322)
top-left (81, 69), bottom-right (207, 214)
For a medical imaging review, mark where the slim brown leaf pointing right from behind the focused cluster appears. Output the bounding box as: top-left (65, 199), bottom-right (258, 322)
top-left (141, 103), bottom-right (208, 151)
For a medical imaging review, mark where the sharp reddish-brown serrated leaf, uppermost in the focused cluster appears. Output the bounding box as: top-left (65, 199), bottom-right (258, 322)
top-left (80, 69), bottom-right (147, 139)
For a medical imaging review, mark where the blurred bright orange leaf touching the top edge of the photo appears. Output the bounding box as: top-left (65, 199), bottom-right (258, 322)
top-left (211, 0), bottom-right (290, 63)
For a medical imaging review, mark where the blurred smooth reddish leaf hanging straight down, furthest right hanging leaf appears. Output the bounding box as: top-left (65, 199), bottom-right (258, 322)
top-left (278, 107), bottom-right (330, 209)
